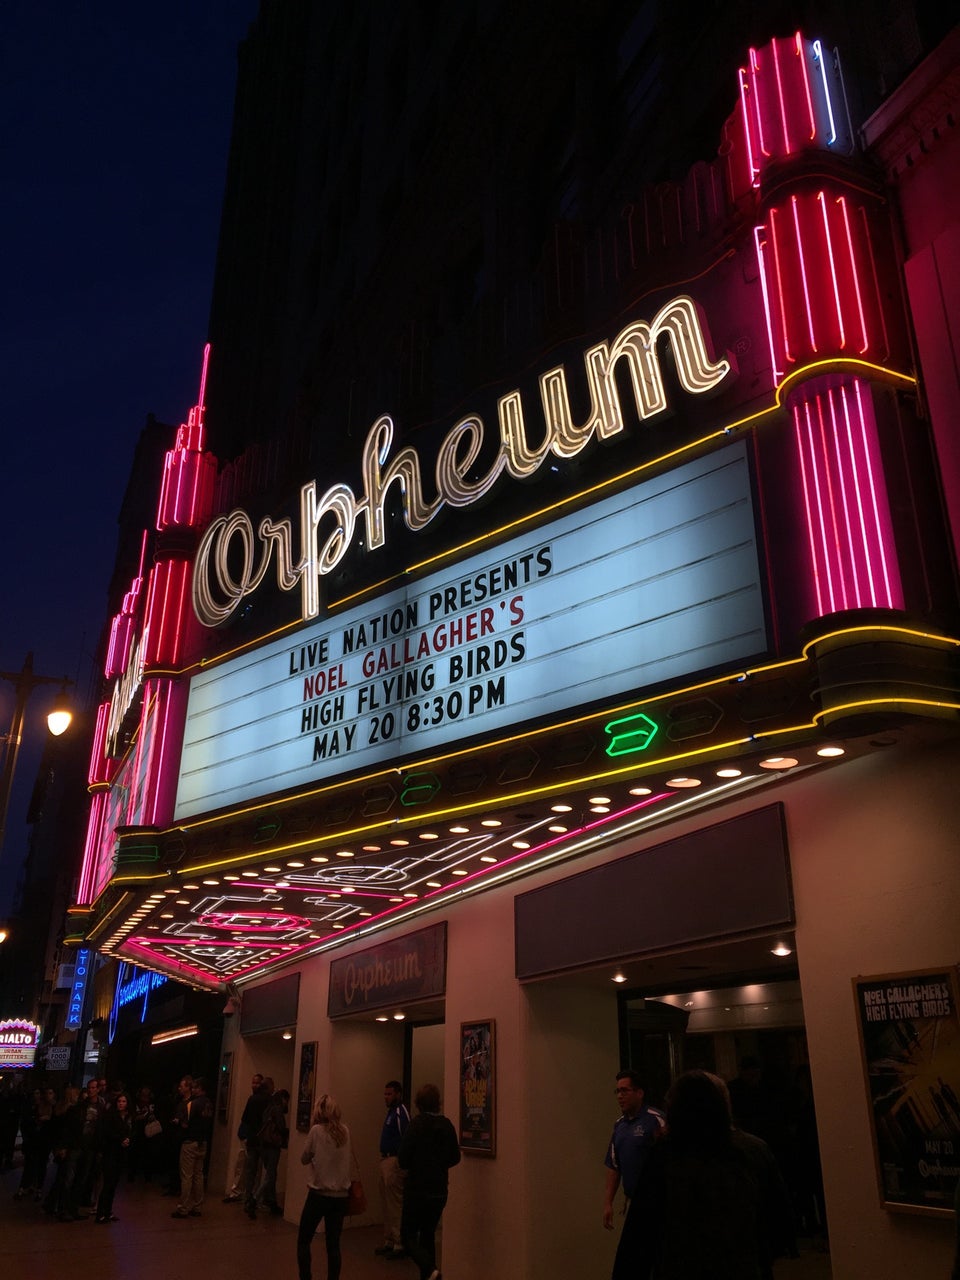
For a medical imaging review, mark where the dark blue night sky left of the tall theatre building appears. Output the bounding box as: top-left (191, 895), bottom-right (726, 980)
top-left (0, 0), bottom-right (257, 919)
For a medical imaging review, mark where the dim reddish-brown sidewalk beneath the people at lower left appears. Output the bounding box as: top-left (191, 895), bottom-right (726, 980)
top-left (0, 1162), bottom-right (391, 1280)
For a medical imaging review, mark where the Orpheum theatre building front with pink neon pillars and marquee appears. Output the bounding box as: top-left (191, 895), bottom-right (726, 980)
top-left (74, 4), bottom-right (960, 1277)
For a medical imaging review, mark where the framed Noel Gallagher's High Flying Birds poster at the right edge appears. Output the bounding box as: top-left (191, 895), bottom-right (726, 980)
top-left (854, 969), bottom-right (960, 1216)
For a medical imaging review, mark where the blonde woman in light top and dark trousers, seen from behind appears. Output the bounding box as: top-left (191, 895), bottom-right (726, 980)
top-left (297, 1093), bottom-right (353, 1280)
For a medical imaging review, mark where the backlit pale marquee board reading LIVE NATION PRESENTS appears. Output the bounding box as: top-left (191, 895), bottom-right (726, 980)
top-left (175, 442), bottom-right (765, 819)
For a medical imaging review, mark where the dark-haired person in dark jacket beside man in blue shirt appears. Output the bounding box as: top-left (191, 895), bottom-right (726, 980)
top-left (397, 1084), bottom-right (460, 1280)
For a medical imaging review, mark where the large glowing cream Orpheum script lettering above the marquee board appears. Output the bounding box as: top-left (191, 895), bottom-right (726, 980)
top-left (193, 296), bottom-right (731, 627)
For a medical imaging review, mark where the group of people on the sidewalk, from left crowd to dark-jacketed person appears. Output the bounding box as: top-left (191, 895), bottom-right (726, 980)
top-left (6, 1073), bottom-right (461, 1280)
